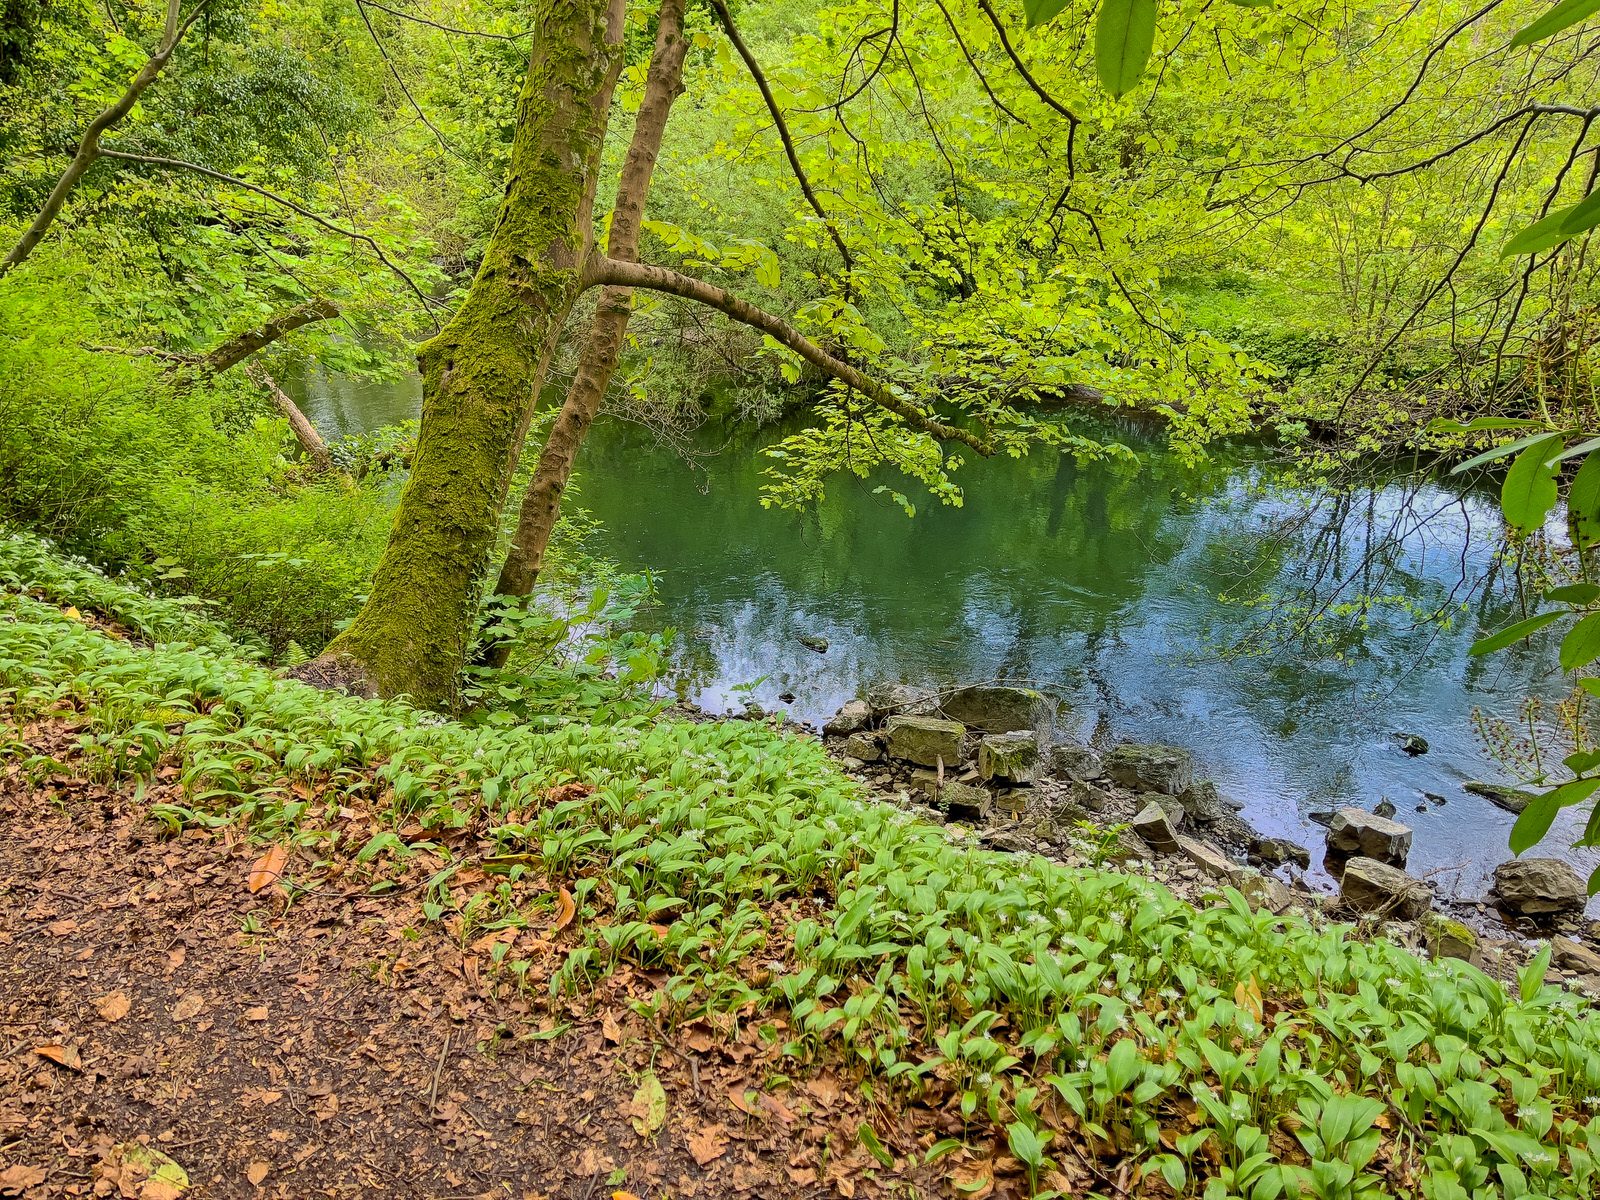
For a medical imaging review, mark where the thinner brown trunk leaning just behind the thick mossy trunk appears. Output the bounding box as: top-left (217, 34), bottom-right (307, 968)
top-left (488, 0), bottom-right (688, 611)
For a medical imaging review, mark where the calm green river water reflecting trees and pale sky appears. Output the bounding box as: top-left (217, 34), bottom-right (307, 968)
top-left (302, 371), bottom-right (1594, 896)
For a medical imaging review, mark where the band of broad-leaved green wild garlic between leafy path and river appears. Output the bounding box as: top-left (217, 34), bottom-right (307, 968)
top-left (0, 534), bottom-right (1600, 1200)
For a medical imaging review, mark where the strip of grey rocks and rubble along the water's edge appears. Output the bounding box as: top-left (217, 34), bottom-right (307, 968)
top-left (822, 685), bottom-right (1600, 998)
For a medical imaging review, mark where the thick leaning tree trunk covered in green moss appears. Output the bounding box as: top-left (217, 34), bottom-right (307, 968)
top-left (298, 0), bottom-right (624, 706)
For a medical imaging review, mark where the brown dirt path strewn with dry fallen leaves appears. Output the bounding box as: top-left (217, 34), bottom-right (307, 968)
top-left (0, 731), bottom-right (1022, 1200)
